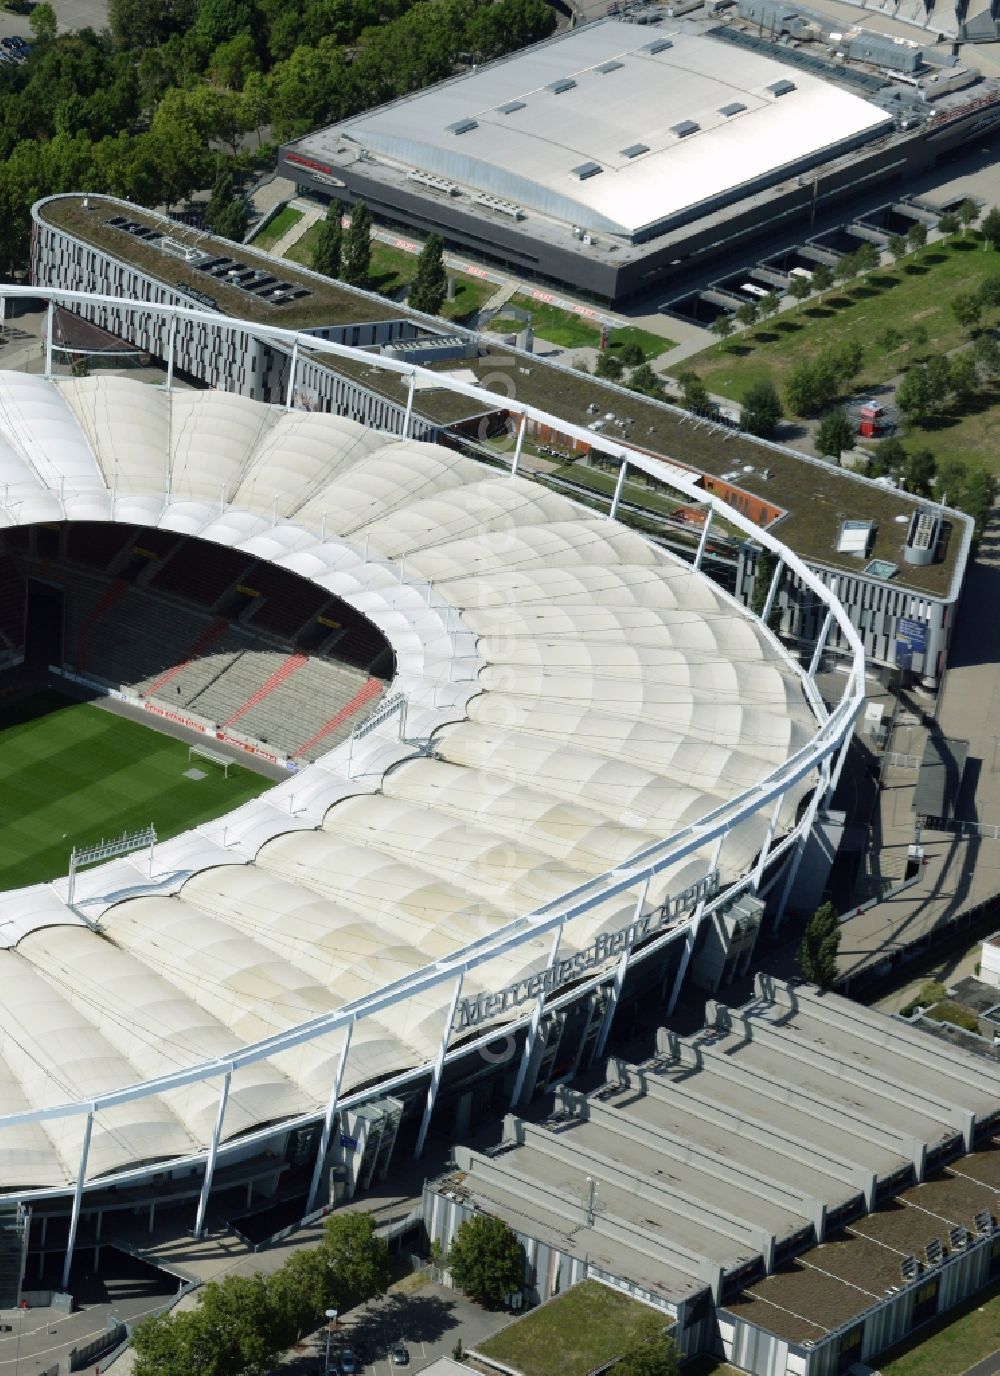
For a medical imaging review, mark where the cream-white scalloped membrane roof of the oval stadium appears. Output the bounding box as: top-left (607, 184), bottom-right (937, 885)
top-left (0, 373), bottom-right (816, 1190)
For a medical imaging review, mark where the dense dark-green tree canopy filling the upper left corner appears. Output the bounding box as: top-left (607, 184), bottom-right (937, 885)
top-left (0, 0), bottom-right (556, 271)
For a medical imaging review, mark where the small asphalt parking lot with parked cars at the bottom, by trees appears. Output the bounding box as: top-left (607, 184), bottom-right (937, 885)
top-left (281, 1273), bottom-right (512, 1376)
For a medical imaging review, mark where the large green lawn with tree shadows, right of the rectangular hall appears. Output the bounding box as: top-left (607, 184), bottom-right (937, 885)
top-left (674, 238), bottom-right (1000, 400)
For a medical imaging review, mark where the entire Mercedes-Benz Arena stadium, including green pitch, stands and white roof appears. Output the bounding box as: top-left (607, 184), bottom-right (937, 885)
top-left (0, 288), bottom-right (864, 1289)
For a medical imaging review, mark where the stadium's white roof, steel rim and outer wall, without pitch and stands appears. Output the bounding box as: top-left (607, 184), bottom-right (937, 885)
top-left (0, 289), bottom-right (864, 1287)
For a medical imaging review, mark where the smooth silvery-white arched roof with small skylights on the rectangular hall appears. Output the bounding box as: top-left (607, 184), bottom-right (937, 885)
top-left (309, 19), bottom-right (891, 238)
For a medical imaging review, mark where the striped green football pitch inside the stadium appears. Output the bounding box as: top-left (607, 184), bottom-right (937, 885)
top-left (0, 691), bottom-right (272, 889)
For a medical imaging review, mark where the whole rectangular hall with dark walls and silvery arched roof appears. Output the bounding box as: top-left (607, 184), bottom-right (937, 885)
top-left (278, 16), bottom-right (1000, 305)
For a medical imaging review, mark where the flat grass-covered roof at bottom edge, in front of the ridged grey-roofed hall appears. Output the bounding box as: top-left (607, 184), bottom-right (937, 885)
top-left (476, 1281), bottom-right (667, 1376)
